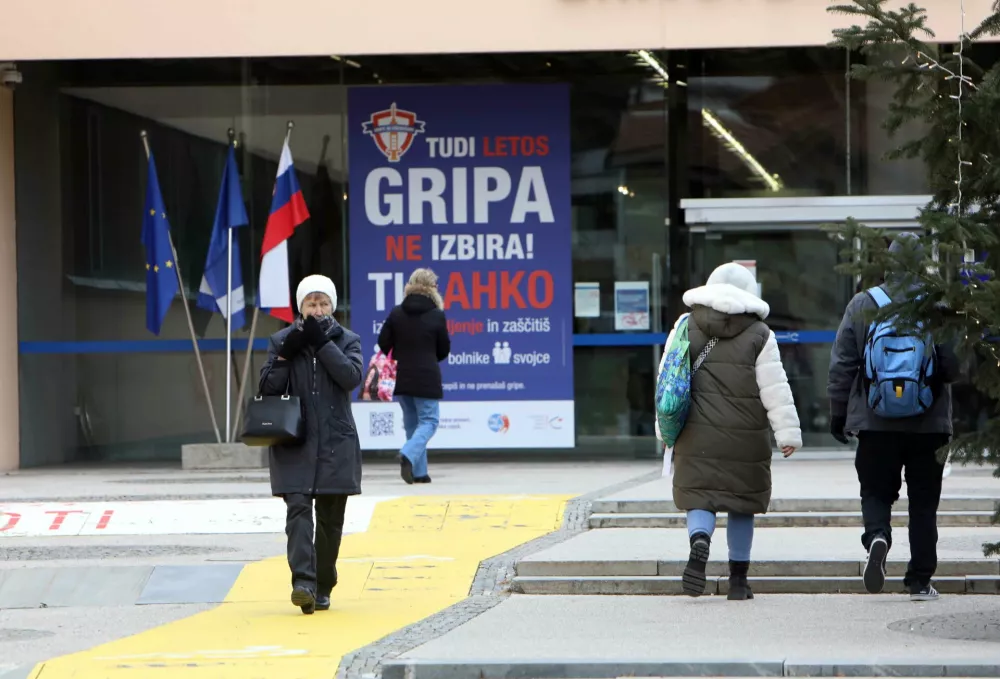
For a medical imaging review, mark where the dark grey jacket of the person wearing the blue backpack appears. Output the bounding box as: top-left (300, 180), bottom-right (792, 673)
top-left (827, 285), bottom-right (960, 435)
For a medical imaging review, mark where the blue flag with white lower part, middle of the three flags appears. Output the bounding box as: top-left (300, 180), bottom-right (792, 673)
top-left (198, 144), bottom-right (250, 330)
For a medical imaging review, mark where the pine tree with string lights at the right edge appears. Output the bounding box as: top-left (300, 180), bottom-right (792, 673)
top-left (827, 0), bottom-right (1000, 555)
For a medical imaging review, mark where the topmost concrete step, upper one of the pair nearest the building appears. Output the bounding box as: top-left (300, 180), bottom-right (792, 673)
top-left (591, 496), bottom-right (1000, 514)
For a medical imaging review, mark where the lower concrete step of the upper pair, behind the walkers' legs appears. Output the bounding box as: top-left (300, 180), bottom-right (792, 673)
top-left (589, 510), bottom-right (993, 528)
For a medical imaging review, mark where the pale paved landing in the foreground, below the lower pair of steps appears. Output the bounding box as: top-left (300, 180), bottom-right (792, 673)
top-left (385, 595), bottom-right (1000, 679)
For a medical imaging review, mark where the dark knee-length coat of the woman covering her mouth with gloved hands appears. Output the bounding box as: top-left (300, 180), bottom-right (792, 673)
top-left (260, 322), bottom-right (362, 495)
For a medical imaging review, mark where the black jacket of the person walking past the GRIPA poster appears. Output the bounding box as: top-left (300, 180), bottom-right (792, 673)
top-left (378, 293), bottom-right (451, 400)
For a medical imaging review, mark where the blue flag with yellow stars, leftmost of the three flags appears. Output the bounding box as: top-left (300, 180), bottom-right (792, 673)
top-left (142, 153), bottom-right (179, 335)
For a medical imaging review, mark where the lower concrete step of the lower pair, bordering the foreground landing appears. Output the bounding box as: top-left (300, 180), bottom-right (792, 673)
top-left (511, 574), bottom-right (1000, 596)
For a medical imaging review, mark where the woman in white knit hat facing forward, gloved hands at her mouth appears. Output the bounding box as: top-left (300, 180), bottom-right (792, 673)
top-left (261, 276), bottom-right (362, 615)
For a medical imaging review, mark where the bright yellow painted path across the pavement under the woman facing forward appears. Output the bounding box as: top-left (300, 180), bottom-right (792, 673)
top-left (30, 496), bottom-right (569, 679)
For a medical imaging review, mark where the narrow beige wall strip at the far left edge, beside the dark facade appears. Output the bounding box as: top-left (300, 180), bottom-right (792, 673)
top-left (0, 88), bottom-right (21, 472)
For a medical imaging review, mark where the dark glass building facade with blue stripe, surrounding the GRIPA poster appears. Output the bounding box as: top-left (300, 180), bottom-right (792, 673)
top-left (15, 48), bottom-right (968, 466)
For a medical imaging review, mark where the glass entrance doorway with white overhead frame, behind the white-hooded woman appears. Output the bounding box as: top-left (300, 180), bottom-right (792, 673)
top-left (681, 196), bottom-right (929, 450)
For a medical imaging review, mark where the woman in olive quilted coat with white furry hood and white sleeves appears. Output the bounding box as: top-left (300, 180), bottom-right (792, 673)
top-left (657, 263), bottom-right (802, 600)
